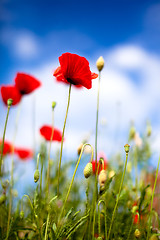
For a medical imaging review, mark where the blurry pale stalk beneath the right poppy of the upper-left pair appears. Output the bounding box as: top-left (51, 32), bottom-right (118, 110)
top-left (6, 103), bottom-right (21, 239)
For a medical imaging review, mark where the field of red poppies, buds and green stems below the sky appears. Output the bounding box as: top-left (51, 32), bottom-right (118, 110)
top-left (0, 53), bottom-right (160, 240)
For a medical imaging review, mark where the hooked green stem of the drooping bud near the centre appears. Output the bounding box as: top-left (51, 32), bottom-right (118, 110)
top-left (60, 143), bottom-right (93, 219)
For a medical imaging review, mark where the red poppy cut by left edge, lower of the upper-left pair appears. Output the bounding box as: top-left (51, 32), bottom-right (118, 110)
top-left (1, 85), bottom-right (22, 106)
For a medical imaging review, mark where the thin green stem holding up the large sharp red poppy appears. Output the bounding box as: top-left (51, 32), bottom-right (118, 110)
top-left (57, 83), bottom-right (71, 196)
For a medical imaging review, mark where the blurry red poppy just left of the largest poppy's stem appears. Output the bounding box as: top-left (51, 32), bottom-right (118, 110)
top-left (40, 125), bottom-right (62, 142)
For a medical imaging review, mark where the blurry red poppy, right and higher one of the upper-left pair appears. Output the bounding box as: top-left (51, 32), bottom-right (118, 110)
top-left (15, 73), bottom-right (41, 95)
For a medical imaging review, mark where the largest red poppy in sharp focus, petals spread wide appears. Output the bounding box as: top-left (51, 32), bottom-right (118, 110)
top-left (53, 53), bottom-right (98, 89)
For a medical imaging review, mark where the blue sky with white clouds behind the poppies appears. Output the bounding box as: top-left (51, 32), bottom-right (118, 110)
top-left (0, 0), bottom-right (160, 170)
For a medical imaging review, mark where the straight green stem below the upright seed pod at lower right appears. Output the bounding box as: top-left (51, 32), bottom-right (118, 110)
top-left (108, 153), bottom-right (128, 239)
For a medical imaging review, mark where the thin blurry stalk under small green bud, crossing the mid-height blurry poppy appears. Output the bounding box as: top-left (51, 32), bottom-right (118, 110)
top-left (47, 108), bottom-right (54, 198)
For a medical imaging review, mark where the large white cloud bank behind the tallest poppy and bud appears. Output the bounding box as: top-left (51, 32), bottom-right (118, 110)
top-left (1, 45), bottom-right (160, 159)
